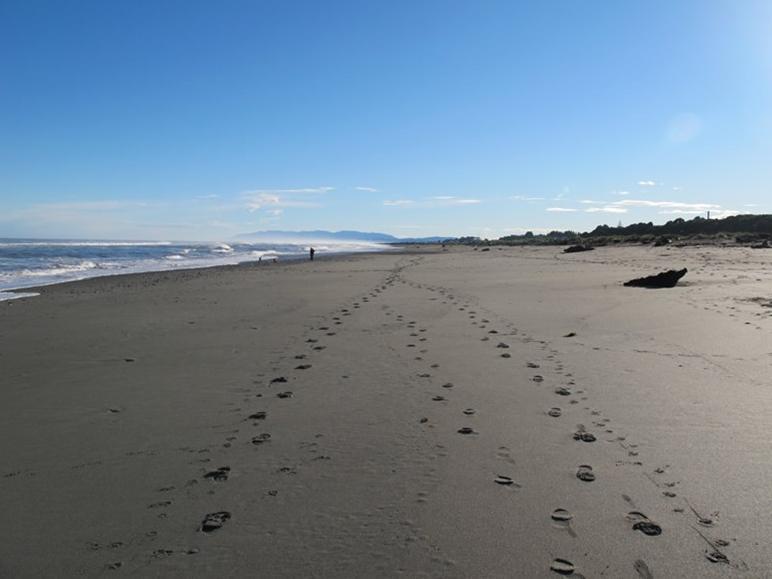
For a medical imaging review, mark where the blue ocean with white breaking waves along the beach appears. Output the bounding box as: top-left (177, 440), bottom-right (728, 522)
top-left (0, 238), bottom-right (388, 300)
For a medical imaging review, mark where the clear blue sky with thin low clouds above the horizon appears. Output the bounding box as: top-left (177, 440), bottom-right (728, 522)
top-left (0, 0), bottom-right (772, 240)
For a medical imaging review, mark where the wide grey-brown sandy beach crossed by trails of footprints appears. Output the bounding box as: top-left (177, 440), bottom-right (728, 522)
top-left (0, 247), bottom-right (772, 578)
